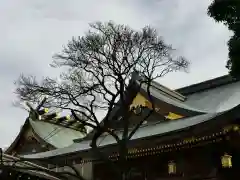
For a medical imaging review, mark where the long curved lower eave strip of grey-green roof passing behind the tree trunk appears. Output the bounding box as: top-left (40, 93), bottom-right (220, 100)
top-left (22, 108), bottom-right (234, 160)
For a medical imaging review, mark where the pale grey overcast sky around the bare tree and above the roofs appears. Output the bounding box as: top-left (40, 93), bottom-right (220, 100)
top-left (0, 0), bottom-right (231, 147)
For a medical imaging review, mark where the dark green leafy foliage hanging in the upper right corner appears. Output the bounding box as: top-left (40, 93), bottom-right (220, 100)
top-left (208, 0), bottom-right (240, 77)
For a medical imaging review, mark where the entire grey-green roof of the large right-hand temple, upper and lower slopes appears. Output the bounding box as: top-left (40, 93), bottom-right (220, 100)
top-left (19, 76), bottom-right (240, 159)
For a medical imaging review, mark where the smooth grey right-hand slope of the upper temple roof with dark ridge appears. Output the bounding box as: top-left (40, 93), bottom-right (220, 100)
top-left (139, 75), bottom-right (240, 114)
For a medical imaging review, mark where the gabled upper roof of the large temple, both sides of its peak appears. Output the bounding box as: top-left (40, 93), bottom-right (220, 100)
top-left (77, 73), bottom-right (240, 140)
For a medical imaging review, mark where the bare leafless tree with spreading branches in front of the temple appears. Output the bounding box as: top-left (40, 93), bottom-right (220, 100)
top-left (16, 22), bottom-right (189, 179)
